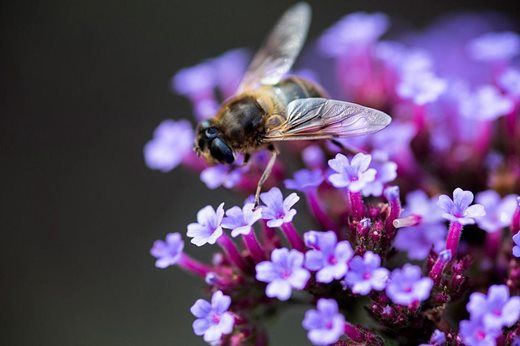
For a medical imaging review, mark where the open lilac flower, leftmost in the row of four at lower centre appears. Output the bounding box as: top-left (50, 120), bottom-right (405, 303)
top-left (256, 248), bottom-right (311, 300)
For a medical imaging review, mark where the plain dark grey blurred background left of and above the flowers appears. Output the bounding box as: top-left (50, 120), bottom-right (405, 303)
top-left (0, 0), bottom-right (519, 346)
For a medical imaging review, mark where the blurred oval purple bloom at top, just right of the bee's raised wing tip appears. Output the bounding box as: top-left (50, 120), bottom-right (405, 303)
top-left (319, 12), bottom-right (389, 56)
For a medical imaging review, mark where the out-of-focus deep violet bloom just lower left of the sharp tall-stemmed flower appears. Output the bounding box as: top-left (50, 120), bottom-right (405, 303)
top-left (394, 223), bottom-right (447, 260)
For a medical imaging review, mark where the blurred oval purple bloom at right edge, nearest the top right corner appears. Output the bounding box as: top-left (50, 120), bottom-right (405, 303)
top-left (468, 31), bottom-right (520, 61)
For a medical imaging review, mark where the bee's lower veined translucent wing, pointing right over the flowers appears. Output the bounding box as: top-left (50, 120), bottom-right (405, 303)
top-left (265, 98), bottom-right (392, 142)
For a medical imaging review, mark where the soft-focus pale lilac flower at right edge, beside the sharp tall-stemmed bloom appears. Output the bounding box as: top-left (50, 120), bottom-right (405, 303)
top-left (476, 190), bottom-right (517, 232)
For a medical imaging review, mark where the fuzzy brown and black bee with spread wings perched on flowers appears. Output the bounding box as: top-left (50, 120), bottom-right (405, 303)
top-left (194, 2), bottom-right (391, 205)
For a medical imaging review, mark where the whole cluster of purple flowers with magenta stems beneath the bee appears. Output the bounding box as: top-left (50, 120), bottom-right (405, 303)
top-left (144, 7), bottom-right (520, 346)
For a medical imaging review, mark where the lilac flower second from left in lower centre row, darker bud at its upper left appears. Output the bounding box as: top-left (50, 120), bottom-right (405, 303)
top-left (303, 231), bottom-right (354, 283)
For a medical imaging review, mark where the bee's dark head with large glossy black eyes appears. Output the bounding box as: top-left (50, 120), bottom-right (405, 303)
top-left (195, 120), bottom-right (235, 164)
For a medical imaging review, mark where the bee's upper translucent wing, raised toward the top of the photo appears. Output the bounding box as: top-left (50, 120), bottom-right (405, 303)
top-left (238, 2), bottom-right (311, 92)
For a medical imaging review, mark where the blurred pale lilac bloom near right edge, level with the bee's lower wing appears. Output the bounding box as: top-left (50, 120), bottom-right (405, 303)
top-left (459, 85), bottom-right (514, 120)
